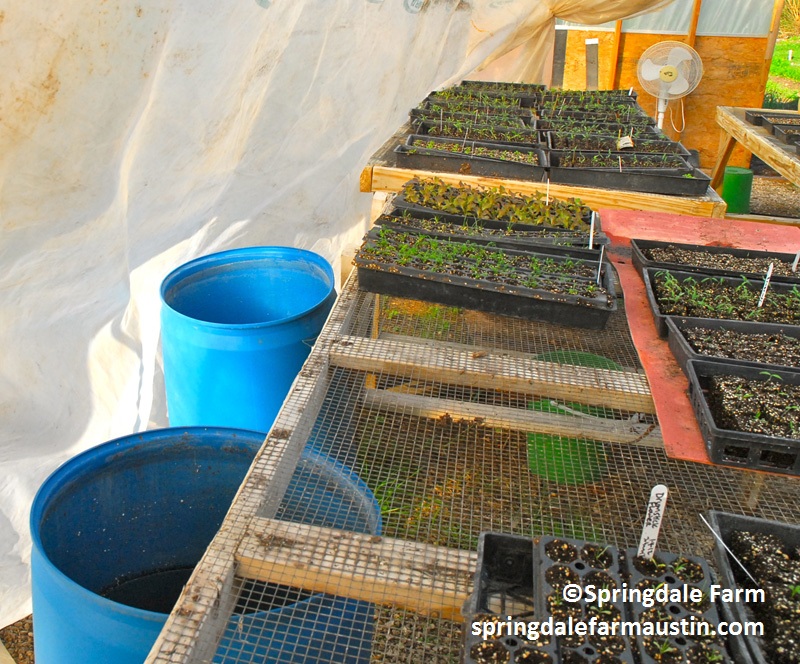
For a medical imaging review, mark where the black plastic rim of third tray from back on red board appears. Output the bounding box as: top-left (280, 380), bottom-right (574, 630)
top-left (666, 316), bottom-right (800, 373)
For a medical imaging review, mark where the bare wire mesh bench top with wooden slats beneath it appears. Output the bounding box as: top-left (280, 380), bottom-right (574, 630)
top-left (147, 272), bottom-right (800, 663)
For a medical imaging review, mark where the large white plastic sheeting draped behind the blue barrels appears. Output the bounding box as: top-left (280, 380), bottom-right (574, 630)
top-left (0, 0), bottom-right (666, 626)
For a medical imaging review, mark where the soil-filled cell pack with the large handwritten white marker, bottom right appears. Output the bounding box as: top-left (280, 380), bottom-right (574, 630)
top-left (625, 548), bottom-right (731, 664)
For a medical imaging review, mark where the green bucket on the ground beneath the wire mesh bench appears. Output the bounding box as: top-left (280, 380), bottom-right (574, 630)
top-left (528, 350), bottom-right (622, 484)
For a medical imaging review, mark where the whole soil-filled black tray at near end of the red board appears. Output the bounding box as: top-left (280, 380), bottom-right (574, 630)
top-left (687, 360), bottom-right (800, 475)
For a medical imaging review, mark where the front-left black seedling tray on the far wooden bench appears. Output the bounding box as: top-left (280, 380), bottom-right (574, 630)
top-left (395, 134), bottom-right (547, 182)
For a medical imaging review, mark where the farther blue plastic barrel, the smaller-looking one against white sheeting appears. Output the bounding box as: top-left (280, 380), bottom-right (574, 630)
top-left (161, 247), bottom-right (336, 431)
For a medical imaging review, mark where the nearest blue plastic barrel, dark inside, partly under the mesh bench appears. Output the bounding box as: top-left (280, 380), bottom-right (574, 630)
top-left (31, 427), bottom-right (381, 664)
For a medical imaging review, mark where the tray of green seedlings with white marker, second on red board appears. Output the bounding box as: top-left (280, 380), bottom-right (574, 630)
top-left (643, 268), bottom-right (800, 337)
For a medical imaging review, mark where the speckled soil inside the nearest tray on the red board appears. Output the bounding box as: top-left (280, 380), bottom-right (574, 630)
top-left (707, 371), bottom-right (800, 440)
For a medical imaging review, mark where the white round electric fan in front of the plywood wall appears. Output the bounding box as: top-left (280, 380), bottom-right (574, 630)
top-left (636, 41), bottom-right (703, 129)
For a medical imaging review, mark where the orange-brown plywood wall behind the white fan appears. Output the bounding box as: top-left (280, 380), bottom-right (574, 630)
top-left (564, 30), bottom-right (769, 168)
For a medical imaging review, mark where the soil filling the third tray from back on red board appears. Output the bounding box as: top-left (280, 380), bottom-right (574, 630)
top-left (683, 327), bottom-right (800, 367)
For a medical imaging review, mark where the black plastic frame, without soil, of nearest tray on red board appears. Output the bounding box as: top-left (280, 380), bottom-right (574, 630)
top-left (687, 360), bottom-right (800, 475)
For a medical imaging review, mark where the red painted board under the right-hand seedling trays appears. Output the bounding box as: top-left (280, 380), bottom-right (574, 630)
top-left (600, 210), bottom-right (800, 463)
